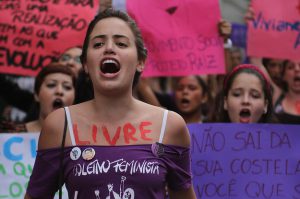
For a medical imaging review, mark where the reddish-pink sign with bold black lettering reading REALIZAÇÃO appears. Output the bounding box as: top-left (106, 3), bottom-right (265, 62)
top-left (0, 0), bottom-right (99, 76)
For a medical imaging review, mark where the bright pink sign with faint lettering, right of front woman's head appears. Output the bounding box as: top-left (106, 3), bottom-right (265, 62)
top-left (127, 0), bottom-right (225, 76)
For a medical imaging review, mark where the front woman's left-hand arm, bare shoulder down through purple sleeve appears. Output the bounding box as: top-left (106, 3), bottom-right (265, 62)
top-left (25, 109), bottom-right (68, 199)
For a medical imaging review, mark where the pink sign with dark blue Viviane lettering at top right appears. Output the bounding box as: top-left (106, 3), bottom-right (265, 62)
top-left (247, 0), bottom-right (300, 60)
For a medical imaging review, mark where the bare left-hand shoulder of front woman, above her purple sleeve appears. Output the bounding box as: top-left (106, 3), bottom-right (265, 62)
top-left (38, 108), bottom-right (65, 150)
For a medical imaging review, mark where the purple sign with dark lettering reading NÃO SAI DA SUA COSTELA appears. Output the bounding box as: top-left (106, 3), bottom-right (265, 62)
top-left (188, 123), bottom-right (300, 199)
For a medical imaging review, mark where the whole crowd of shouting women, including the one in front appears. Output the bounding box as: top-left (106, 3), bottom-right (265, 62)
top-left (0, 1), bottom-right (300, 199)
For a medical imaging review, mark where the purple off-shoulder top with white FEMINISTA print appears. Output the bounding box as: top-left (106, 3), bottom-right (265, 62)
top-left (27, 108), bottom-right (191, 199)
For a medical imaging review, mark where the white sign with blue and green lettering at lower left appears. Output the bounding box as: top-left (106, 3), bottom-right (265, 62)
top-left (0, 133), bottom-right (68, 199)
